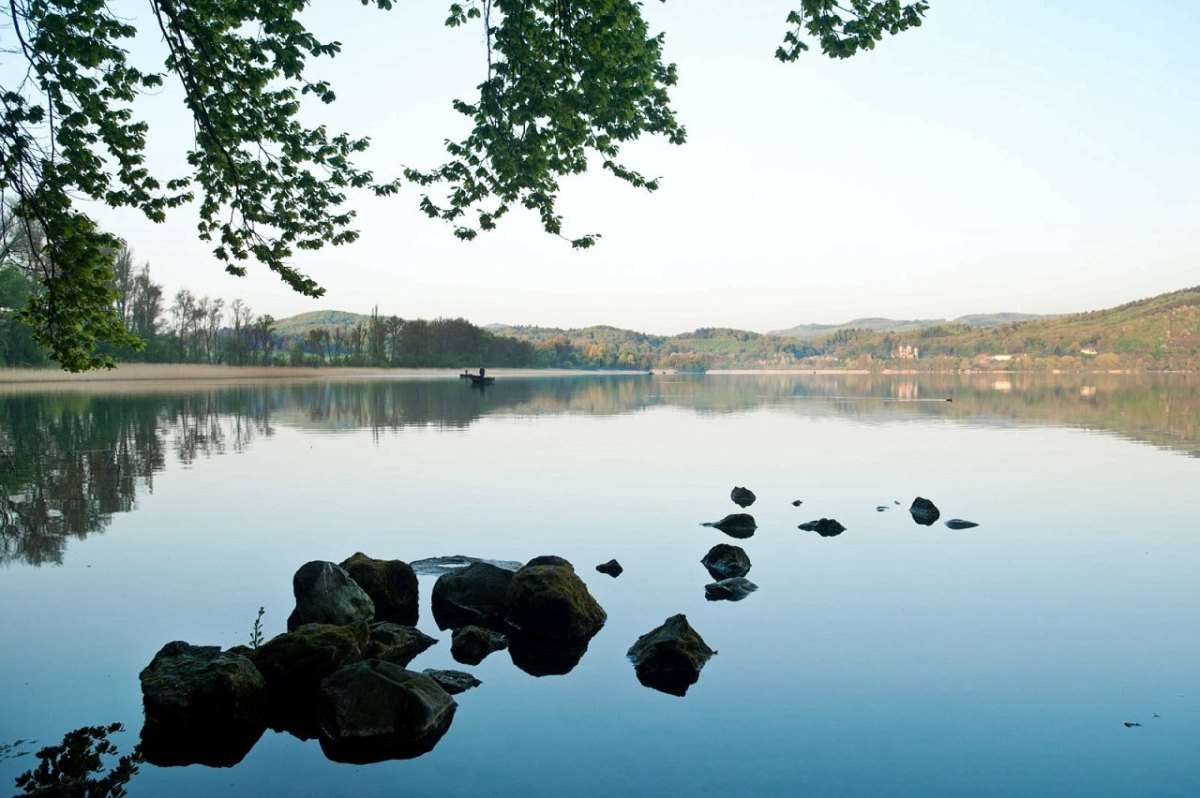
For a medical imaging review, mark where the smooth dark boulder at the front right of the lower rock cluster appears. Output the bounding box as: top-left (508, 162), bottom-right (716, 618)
top-left (317, 660), bottom-right (457, 764)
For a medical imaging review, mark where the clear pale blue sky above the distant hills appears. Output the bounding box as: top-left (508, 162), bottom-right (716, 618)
top-left (82, 0), bottom-right (1200, 334)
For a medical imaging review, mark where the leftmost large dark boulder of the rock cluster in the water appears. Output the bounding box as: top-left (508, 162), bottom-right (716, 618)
top-left (139, 641), bottom-right (268, 767)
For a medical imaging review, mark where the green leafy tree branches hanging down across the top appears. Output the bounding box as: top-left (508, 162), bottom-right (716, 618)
top-left (0, 0), bottom-right (926, 370)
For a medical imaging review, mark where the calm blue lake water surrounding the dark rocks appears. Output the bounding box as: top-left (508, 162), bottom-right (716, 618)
top-left (0, 372), bottom-right (1200, 797)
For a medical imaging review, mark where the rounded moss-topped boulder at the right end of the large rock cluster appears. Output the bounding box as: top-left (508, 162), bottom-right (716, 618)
top-left (508, 557), bottom-right (608, 641)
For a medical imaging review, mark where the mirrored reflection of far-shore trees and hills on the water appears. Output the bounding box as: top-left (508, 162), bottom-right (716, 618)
top-left (0, 374), bottom-right (1200, 565)
